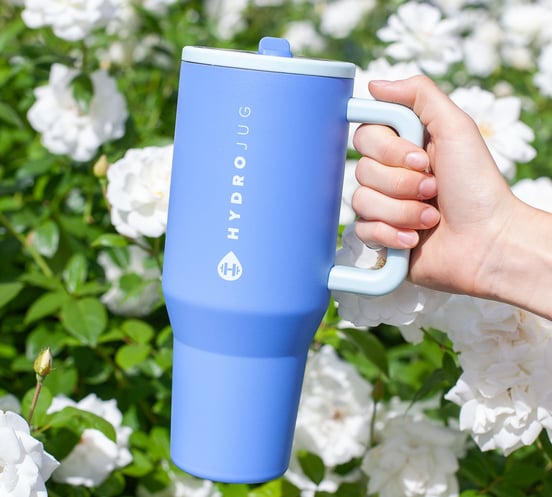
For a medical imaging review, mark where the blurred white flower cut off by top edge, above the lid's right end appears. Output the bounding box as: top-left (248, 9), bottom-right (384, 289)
top-left (320, 0), bottom-right (376, 38)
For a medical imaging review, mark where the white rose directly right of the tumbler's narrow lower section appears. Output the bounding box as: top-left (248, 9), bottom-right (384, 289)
top-left (294, 345), bottom-right (373, 467)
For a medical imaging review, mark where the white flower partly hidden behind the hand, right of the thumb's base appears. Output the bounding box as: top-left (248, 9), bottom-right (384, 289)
top-left (450, 86), bottom-right (536, 178)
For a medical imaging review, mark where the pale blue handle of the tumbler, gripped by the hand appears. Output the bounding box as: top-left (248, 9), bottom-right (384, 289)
top-left (328, 98), bottom-right (424, 296)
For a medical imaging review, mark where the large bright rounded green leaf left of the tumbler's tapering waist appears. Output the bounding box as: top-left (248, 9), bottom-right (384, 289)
top-left (61, 297), bottom-right (107, 347)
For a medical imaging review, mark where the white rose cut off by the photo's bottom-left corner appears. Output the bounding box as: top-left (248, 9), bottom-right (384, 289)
top-left (0, 410), bottom-right (59, 497)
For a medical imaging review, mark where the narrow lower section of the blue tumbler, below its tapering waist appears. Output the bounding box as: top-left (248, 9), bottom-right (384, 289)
top-left (171, 339), bottom-right (307, 483)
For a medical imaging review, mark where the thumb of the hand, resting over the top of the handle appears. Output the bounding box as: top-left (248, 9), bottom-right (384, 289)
top-left (369, 76), bottom-right (475, 136)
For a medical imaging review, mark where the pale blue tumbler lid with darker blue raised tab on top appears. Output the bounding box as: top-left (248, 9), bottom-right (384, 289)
top-left (182, 37), bottom-right (356, 79)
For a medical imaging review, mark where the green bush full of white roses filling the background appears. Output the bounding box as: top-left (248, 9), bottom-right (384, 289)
top-left (0, 0), bottom-right (552, 497)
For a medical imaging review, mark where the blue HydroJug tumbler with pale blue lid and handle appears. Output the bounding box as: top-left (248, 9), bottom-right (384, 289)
top-left (162, 38), bottom-right (423, 483)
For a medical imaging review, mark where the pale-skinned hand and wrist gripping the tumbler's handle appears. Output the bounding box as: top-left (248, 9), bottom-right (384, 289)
top-left (353, 76), bottom-right (552, 319)
